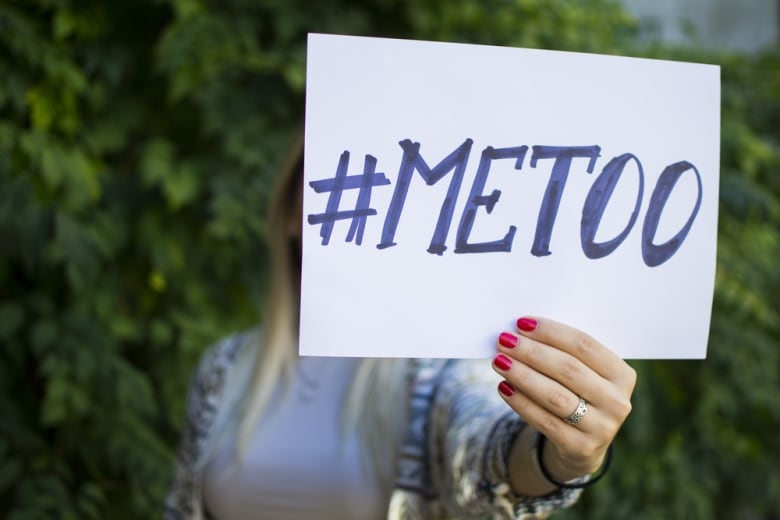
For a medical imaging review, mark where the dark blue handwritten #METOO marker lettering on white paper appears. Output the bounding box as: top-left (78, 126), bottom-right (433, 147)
top-left (308, 139), bottom-right (703, 267)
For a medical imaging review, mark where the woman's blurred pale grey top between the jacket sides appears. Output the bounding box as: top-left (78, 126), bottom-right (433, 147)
top-left (203, 357), bottom-right (390, 520)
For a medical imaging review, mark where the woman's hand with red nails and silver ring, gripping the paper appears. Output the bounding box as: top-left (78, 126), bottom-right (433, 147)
top-left (493, 317), bottom-right (636, 494)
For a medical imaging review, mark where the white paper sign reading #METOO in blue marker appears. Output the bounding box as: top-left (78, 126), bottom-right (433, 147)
top-left (300, 34), bottom-right (720, 358)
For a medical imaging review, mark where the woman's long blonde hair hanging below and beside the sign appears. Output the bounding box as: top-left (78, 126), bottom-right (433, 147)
top-left (237, 135), bottom-right (409, 484)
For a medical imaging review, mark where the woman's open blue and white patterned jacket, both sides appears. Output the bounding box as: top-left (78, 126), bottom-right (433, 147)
top-left (164, 333), bottom-right (580, 520)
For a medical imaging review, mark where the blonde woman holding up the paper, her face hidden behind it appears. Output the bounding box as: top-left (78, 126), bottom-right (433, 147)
top-left (166, 136), bottom-right (636, 520)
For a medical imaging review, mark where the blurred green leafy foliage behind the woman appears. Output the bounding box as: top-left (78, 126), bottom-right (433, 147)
top-left (0, 0), bottom-right (780, 519)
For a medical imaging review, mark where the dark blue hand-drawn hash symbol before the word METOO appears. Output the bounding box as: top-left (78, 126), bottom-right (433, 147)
top-left (308, 151), bottom-right (390, 245)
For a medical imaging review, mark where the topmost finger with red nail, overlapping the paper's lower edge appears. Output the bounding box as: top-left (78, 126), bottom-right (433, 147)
top-left (517, 316), bottom-right (628, 382)
